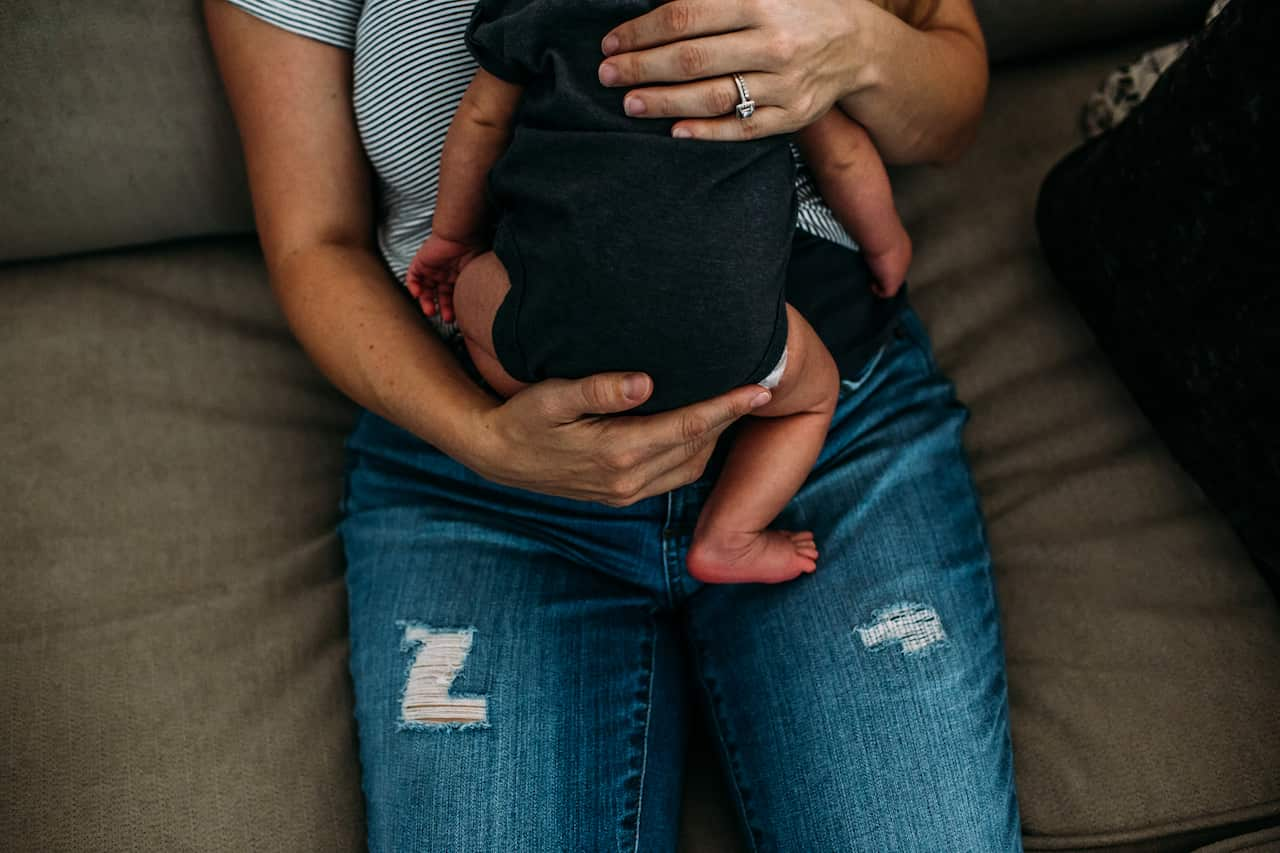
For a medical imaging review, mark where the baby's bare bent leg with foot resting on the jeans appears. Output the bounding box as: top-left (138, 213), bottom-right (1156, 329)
top-left (689, 305), bottom-right (840, 583)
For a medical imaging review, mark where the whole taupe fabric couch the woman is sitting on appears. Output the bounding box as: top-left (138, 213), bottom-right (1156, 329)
top-left (0, 0), bottom-right (1280, 853)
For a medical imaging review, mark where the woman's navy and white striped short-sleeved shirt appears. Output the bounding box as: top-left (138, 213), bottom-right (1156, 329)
top-left (230, 0), bottom-right (856, 337)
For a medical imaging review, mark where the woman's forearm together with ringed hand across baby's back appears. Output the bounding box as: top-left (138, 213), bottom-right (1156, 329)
top-left (600, 0), bottom-right (987, 163)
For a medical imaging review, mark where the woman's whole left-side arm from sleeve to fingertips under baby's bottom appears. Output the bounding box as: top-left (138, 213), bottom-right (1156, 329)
top-left (205, 0), bottom-right (768, 506)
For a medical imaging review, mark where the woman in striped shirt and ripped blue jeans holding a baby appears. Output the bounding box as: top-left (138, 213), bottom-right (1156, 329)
top-left (206, 0), bottom-right (1020, 850)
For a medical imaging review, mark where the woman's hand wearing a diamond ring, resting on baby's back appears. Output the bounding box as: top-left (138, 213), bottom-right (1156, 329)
top-left (599, 0), bottom-right (892, 140)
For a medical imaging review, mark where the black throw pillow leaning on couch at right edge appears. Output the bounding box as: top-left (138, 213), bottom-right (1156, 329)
top-left (1037, 0), bottom-right (1280, 589)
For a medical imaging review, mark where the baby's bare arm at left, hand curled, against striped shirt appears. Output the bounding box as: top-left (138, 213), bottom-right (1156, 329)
top-left (406, 68), bottom-right (524, 323)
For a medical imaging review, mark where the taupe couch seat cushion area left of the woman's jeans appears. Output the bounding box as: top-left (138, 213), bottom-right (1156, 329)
top-left (0, 238), bottom-right (362, 853)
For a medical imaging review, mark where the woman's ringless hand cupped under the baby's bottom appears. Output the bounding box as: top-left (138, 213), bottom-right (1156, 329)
top-left (463, 373), bottom-right (771, 507)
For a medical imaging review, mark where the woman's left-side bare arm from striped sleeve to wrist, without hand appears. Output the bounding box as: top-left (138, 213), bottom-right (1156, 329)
top-left (205, 0), bottom-right (486, 456)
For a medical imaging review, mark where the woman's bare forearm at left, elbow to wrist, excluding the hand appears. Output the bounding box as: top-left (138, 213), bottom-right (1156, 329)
top-left (270, 243), bottom-right (498, 465)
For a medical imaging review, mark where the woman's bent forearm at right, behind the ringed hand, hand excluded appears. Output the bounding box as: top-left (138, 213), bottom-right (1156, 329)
top-left (840, 3), bottom-right (987, 164)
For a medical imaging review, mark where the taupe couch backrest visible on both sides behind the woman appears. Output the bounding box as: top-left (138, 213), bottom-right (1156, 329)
top-left (0, 0), bottom-right (1207, 261)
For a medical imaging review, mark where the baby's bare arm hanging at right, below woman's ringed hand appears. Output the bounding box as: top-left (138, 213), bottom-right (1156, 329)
top-left (796, 108), bottom-right (911, 297)
